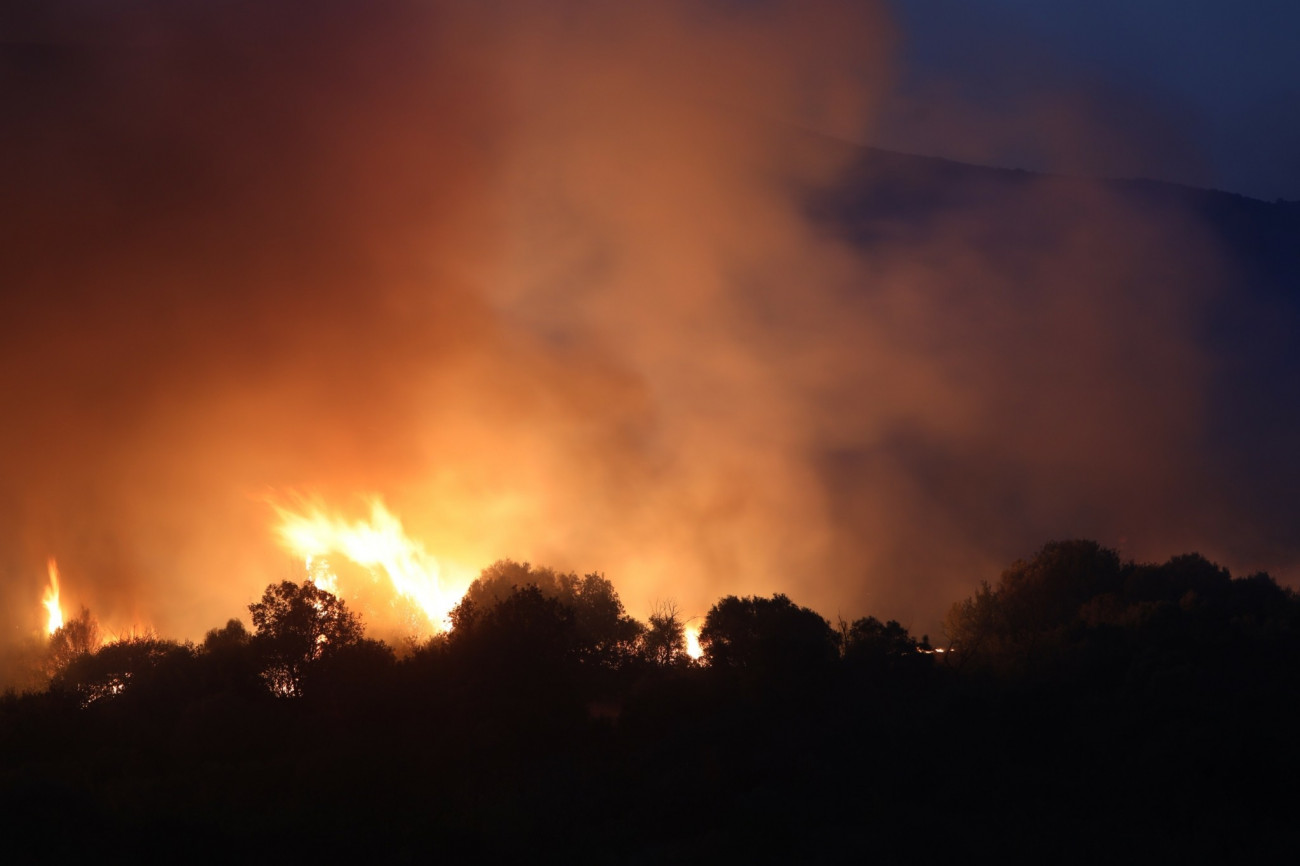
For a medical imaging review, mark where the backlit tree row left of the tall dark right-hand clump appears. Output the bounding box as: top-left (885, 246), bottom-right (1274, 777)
top-left (20, 559), bottom-right (933, 706)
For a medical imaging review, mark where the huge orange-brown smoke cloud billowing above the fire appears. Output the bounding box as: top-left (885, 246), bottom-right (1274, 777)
top-left (0, 0), bottom-right (1300, 650)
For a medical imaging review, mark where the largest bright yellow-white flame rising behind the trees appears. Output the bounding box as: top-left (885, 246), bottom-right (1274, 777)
top-left (272, 498), bottom-right (468, 631)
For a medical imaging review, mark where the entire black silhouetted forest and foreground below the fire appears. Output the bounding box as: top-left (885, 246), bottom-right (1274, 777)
top-left (0, 540), bottom-right (1300, 863)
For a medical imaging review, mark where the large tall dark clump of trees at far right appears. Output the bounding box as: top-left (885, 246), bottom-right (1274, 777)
top-left (945, 541), bottom-right (1297, 684)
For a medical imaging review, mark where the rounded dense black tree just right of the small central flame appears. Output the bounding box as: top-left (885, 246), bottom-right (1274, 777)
top-left (699, 594), bottom-right (840, 677)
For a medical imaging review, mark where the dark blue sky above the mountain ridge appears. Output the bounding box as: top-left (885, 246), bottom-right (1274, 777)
top-left (879, 0), bottom-right (1300, 199)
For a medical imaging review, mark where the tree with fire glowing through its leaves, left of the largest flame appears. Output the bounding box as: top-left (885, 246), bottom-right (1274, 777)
top-left (248, 580), bottom-right (363, 697)
